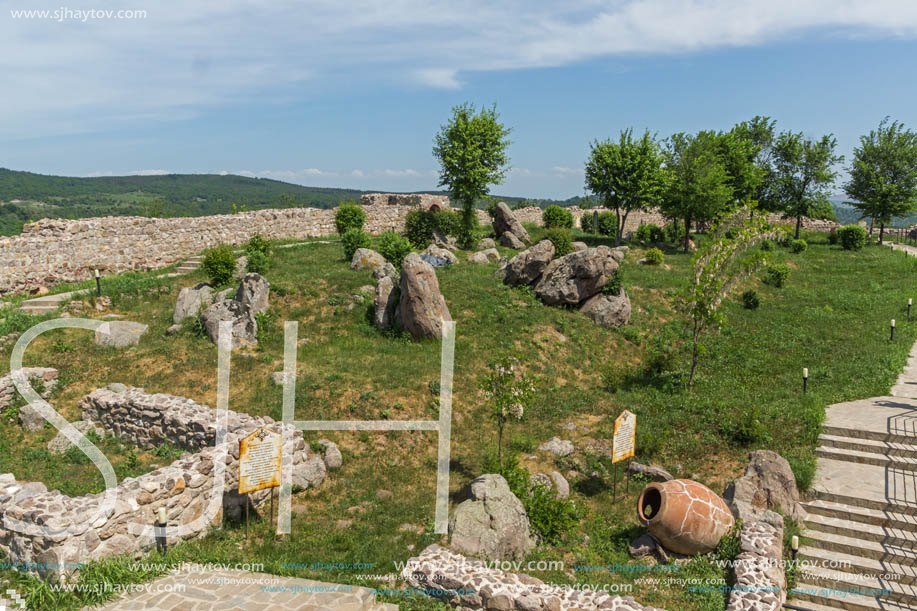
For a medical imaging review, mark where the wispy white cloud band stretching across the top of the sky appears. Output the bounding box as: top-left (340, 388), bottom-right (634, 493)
top-left (0, 0), bottom-right (917, 138)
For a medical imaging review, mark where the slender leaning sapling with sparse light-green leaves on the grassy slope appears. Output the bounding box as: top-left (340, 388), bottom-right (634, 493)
top-left (682, 203), bottom-right (773, 386)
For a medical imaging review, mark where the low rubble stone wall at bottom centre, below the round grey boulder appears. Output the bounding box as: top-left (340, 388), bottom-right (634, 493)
top-left (401, 545), bottom-right (658, 611)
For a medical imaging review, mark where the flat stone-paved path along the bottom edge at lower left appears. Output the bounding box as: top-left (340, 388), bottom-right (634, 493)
top-left (84, 570), bottom-right (398, 611)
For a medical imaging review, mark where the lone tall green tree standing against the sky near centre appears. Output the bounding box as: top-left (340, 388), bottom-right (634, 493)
top-left (433, 103), bottom-right (511, 247)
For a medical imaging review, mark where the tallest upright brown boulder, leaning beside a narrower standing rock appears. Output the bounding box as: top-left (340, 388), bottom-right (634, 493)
top-left (397, 252), bottom-right (452, 339)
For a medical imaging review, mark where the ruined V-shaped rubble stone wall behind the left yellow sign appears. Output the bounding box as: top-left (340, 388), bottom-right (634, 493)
top-left (0, 385), bottom-right (325, 580)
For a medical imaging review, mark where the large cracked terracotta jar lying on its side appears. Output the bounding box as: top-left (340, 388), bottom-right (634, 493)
top-left (637, 479), bottom-right (735, 555)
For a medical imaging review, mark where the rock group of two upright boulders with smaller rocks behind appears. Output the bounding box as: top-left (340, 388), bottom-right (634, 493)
top-left (350, 246), bottom-right (455, 339)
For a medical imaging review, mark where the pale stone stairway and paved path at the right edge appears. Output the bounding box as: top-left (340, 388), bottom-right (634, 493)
top-left (794, 340), bottom-right (917, 611)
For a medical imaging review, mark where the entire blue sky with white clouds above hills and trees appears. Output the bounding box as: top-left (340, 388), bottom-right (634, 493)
top-left (0, 0), bottom-right (917, 198)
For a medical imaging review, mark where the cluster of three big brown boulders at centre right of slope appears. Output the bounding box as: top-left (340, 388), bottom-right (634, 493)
top-left (497, 240), bottom-right (631, 327)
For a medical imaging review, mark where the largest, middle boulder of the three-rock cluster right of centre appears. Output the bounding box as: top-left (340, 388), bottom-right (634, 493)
top-left (535, 246), bottom-right (618, 305)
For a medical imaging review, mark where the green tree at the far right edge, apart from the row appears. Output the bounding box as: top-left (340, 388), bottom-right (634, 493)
top-left (844, 117), bottom-right (917, 244)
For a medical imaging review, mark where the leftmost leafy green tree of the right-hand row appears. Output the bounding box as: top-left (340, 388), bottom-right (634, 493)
top-left (586, 128), bottom-right (666, 246)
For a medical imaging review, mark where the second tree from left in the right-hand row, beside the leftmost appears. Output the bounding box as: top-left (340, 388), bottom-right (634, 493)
top-left (661, 131), bottom-right (733, 252)
